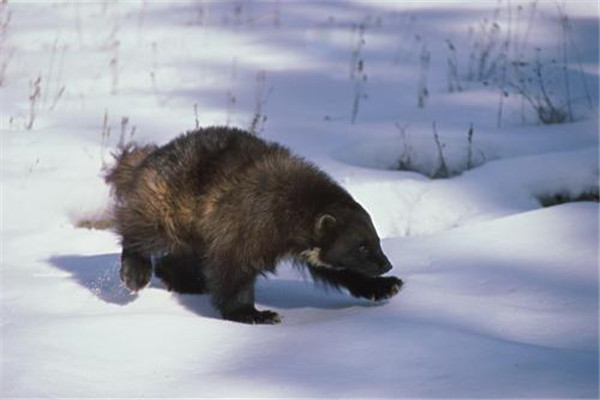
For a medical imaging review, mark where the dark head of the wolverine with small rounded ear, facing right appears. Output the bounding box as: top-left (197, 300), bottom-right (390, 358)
top-left (302, 204), bottom-right (392, 276)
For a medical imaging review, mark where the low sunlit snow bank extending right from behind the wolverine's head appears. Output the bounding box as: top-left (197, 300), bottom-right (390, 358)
top-left (341, 149), bottom-right (599, 237)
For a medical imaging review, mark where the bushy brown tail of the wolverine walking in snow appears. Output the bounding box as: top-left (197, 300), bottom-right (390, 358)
top-left (104, 143), bottom-right (157, 201)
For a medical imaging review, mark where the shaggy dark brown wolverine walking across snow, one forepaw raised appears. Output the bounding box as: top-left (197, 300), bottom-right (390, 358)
top-left (105, 127), bottom-right (402, 324)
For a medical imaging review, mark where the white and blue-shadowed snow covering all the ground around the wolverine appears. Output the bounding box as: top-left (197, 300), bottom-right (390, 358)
top-left (0, 1), bottom-right (599, 398)
